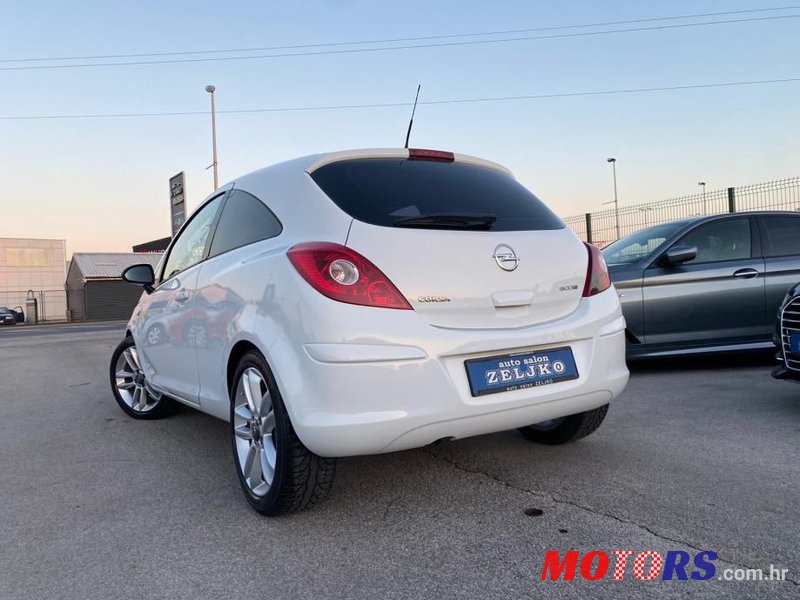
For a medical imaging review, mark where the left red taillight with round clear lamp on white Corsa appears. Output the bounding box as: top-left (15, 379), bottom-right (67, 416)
top-left (286, 242), bottom-right (411, 310)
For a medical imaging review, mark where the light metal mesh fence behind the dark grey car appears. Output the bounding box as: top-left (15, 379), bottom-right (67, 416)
top-left (564, 177), bottom-right (800, 248)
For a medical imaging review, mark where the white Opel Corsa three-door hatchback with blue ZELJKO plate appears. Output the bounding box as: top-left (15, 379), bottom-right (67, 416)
top-left (110, 149), bottom-right (628, 515)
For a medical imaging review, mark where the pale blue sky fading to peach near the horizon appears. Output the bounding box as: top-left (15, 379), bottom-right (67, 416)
top-left (0, 0), bottom-right (800, 253)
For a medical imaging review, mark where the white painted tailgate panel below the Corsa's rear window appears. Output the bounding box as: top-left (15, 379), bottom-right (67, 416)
top-left (347, 221), bottom-right (588, 329)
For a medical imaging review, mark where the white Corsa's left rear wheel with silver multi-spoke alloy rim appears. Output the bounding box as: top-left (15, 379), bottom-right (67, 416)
top-left (230, 351), bottom-right (336, 516)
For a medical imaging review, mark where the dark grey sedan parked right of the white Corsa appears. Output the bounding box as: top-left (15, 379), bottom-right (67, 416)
top-left (603, 212), bottom-right (800, 358)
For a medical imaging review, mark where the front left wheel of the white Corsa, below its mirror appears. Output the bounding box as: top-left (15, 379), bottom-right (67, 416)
top-left (109, 336), bottom-right (177, 420)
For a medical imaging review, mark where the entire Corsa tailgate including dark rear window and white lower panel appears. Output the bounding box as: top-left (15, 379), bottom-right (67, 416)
top-left (309, 150), bottom-right (588, 329)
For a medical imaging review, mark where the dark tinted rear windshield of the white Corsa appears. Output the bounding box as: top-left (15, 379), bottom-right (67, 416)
top-left (311, 158), bottom-right (564, 231)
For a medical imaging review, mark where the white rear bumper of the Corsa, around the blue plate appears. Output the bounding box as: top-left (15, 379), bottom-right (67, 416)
top-left (268, 288), bottom-right (628, 456)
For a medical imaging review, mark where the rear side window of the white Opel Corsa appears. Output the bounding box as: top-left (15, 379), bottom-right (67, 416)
top-left (209, 190), bottom-right (283, 256)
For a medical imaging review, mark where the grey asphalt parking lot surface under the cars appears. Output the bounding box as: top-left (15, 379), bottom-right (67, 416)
top-left (0, 324), bottom-right (800, 600)
